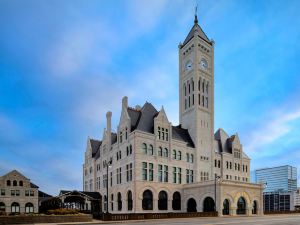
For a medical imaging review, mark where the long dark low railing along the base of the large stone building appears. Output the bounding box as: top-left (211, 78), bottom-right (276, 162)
top-left (94, 212), bottom-right (218, 221)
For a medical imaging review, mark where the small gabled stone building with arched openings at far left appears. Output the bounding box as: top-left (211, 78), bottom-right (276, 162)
top-left (0, 170), bottom-right (39, 214)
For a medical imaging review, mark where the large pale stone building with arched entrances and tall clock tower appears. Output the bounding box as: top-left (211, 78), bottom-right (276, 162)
top-left (83, 16), bottom-right (263, 216)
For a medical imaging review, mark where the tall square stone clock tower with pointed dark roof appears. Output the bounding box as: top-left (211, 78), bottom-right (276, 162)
top-left (178, 15), bottom-right (214, 182)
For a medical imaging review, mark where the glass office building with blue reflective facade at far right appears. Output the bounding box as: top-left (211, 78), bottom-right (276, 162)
top-left (255, 165), bottom-right (297, 192)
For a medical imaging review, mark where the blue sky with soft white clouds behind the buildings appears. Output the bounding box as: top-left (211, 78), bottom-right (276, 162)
top-left (0, 0), bottom-right (300, 194)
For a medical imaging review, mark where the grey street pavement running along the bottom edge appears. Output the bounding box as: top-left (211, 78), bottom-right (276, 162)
top-left (16, 214), bottom-right (300, 225)
